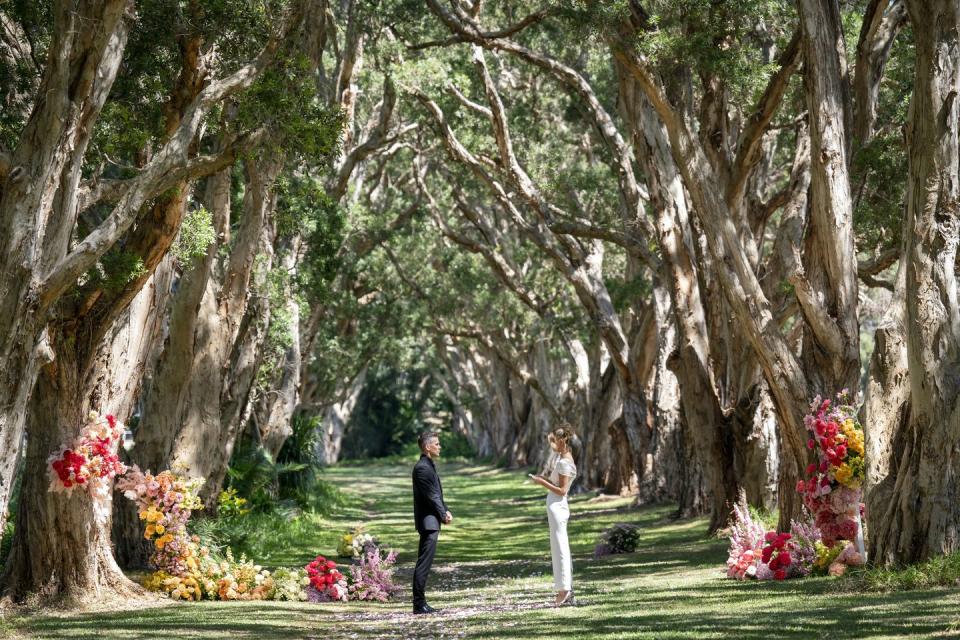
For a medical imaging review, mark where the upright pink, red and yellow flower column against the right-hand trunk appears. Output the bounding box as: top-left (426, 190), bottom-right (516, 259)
top-left (797, 389), bottom-right (865, 547)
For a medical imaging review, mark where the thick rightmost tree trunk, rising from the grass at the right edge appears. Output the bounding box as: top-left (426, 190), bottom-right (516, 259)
top-left (870, 0), bottom-right (960, 563)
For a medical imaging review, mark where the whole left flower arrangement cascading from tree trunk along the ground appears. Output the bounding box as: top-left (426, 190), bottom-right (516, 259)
top-left (49, 424), bottom-right (397, 602)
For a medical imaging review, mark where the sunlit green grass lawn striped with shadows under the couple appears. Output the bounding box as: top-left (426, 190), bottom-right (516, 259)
top-left (7, 464), bottom-right (960, 640)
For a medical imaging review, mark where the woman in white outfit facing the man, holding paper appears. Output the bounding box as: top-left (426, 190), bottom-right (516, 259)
top-left (530, 426), bottom-right (577, 606)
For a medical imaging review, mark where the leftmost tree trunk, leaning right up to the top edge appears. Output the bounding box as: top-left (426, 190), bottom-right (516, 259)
top-left (0, 0), bottom-right (128, 544)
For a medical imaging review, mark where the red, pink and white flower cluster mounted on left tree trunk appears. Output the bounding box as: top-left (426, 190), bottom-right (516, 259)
top-left (47, 411), bottom-right (127, 523)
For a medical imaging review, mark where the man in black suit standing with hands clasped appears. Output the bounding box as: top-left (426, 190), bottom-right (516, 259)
top-left (413, 431), bottom-right (453, 613)
